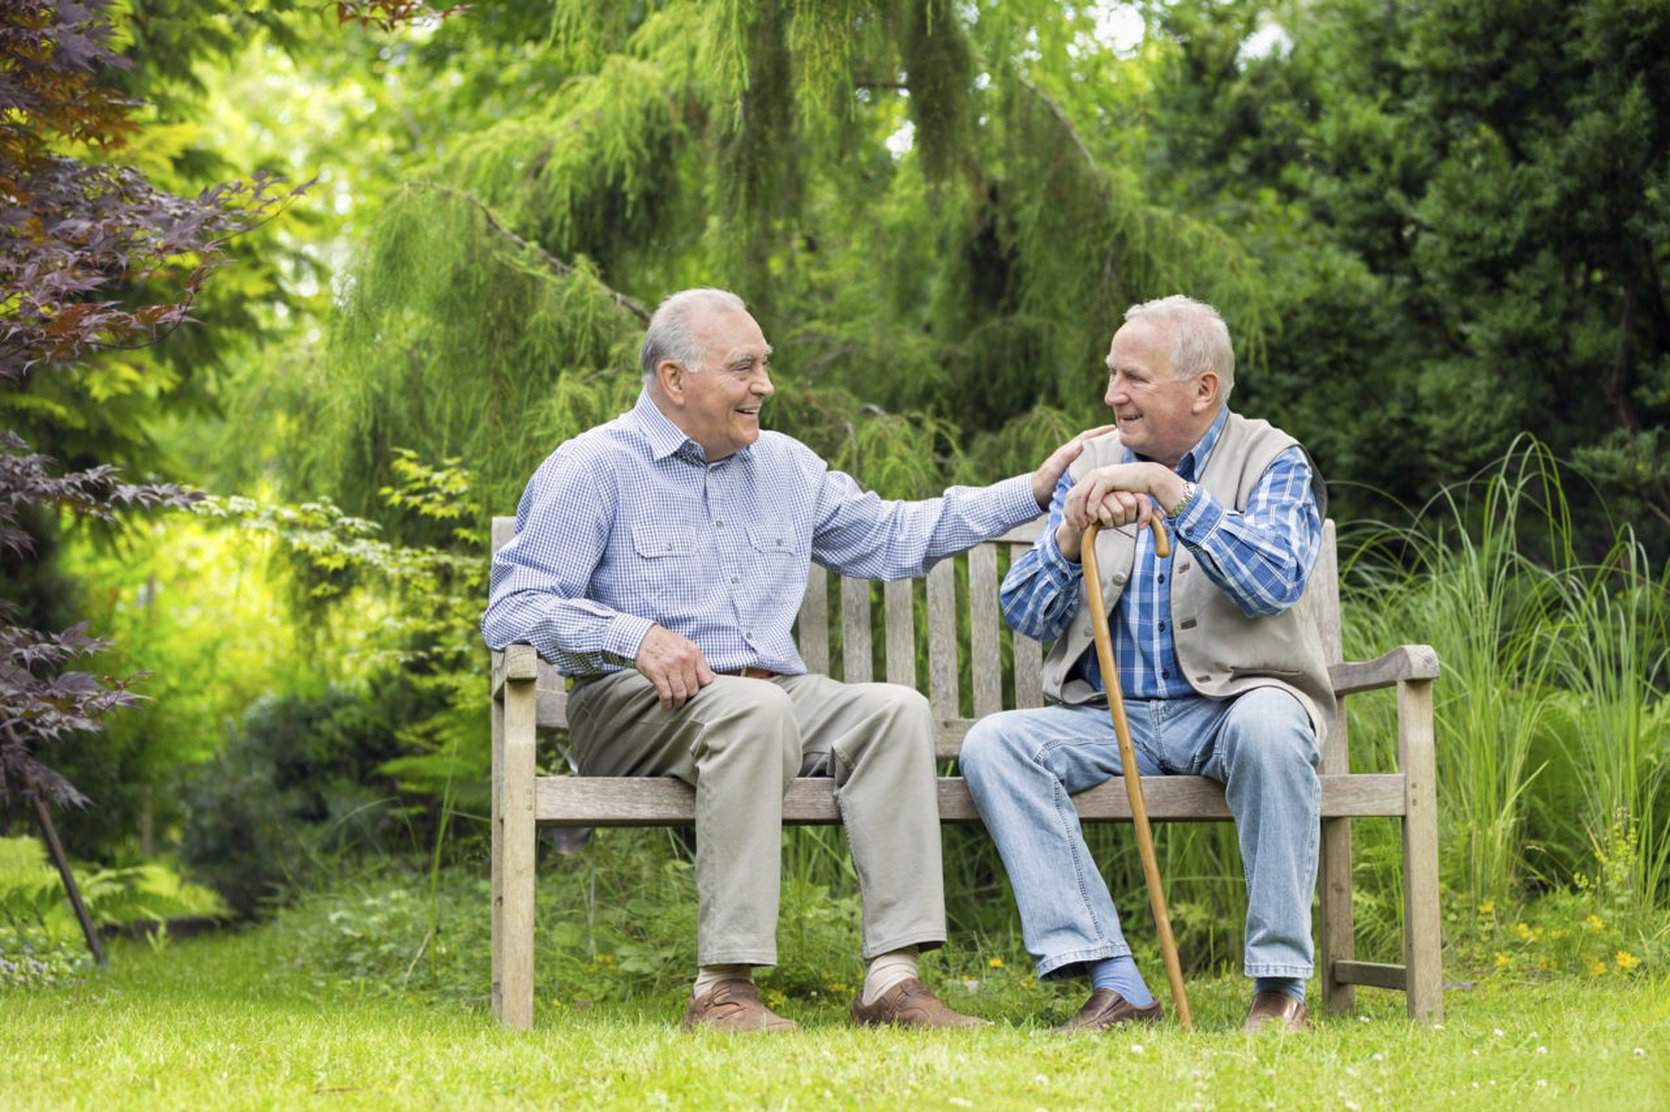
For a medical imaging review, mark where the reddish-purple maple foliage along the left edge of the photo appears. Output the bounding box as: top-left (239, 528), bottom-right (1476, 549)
top-left (0, 0), bottom-right (297, 803)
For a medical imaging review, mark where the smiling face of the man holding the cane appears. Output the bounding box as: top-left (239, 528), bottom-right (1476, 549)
top-left (1102, 317), bottom-right (1217, 468)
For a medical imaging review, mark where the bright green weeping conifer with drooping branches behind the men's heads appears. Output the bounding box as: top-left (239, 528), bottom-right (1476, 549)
top-left (292, 0), bottom-right (1269, 527)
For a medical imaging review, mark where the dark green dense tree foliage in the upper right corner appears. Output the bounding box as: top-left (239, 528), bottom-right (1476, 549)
top-left (1149, 0), bottom-right (1670, 537)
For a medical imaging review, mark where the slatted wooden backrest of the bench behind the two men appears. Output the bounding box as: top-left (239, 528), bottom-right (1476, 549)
top-left (493, 518), bottom-right (1343, 758)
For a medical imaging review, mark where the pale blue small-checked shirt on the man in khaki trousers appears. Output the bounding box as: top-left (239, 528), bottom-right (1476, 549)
top-left (481, 394), bottom-right (1039, 676)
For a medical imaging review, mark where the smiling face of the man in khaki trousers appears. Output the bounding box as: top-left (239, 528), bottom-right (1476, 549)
top-left (656, 306), bottom-right (775, 462)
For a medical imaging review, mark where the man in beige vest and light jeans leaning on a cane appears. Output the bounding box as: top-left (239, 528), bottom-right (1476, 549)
top-left (962, 296), bottom-right (1334, 1030)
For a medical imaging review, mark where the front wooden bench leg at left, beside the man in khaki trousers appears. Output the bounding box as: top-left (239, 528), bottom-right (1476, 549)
top-left (493, 680), bottom-right (536, 1030)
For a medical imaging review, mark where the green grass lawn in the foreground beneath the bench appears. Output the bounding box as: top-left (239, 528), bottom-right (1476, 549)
top-left (0, 930), bottom-right (1670, 1112)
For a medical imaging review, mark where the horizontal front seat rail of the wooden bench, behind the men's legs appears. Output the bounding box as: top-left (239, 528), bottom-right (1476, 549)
top-left (534, 773), bottom-right (1403, 826)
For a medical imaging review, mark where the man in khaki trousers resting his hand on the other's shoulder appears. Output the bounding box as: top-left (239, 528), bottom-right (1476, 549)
top-left (481, 289), bottom-right (1101, 1032)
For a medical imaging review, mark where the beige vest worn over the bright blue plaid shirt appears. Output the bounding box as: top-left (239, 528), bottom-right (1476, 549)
top-left (1044, 412), bottom-right (1336, 738)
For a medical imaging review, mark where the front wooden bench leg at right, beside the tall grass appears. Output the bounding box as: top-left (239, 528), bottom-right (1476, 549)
top-left (1398, 680), bottom-right (1445, 1022)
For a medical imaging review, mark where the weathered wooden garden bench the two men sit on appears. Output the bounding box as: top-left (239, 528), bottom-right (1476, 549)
top-left (493, 518), bottom-right (1443, 1029)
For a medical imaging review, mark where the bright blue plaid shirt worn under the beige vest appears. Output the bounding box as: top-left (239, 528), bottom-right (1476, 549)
top-left (1000, 409), bottom-right (1323, 700)
